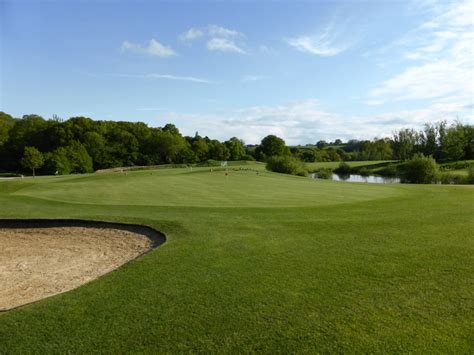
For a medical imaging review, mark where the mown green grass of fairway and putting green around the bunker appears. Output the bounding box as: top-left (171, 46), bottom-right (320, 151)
top-left (0, 165), bottom-right (474, 353)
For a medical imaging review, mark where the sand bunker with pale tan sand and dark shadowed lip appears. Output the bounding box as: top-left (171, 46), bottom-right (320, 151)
top-left (0, 221), bottom-right (164, 311)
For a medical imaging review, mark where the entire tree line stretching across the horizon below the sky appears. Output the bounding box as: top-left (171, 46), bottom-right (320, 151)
top-left (0, 112), bottom-right (474, 174)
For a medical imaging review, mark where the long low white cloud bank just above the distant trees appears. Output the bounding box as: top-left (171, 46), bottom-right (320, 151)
top-left (158, 97), bottom-right (474, 144)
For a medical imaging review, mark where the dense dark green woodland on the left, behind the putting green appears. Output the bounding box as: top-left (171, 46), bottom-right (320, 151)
top-left (0, 113), bottom-right (248, 174)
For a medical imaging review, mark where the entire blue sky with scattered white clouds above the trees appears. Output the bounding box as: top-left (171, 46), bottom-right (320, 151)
top-left (0, 0), bottom-right (474, 145)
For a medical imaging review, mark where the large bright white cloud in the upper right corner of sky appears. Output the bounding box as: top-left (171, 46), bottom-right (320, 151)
top-left (369, 0), bottom-right (474, 104)
